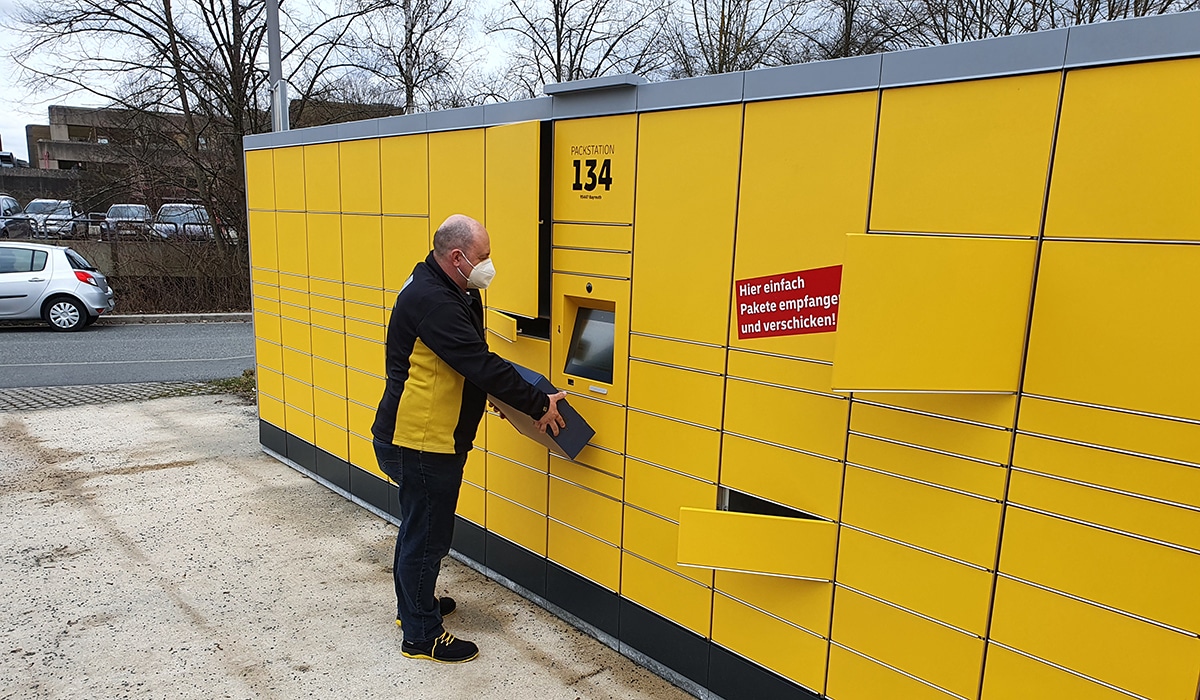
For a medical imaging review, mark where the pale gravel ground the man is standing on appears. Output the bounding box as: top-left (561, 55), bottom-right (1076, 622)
top-left (0, 396), bottom-right (688, 700)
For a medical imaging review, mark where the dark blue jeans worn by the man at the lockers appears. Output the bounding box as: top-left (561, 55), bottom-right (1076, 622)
top-left (374, 441), bottom-right (467, 644)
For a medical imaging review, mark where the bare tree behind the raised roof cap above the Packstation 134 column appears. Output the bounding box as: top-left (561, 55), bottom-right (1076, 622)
top-left (487, 0), bottom-right (666, 97)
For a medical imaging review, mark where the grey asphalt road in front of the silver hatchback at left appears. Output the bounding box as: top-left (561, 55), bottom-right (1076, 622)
top-left (0, 323), bottom-right (254, 389)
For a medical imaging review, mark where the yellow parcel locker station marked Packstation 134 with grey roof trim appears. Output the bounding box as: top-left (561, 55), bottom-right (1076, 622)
top-left (246, 12), bottom-right (1200, 700)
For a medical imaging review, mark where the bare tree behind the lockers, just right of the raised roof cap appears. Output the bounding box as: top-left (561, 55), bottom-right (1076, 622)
top-left (668, 0), bottom-right (804, 77)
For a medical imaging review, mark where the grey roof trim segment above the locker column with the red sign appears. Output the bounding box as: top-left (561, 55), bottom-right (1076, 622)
top-left (744, 54), bottom-right (883, 102)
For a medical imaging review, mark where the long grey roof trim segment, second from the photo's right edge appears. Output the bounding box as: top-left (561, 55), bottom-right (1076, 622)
top-left (880, 29), bottom-right (1067, 88)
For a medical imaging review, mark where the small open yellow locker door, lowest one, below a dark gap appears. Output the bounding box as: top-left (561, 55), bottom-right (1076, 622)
top-left (678, 508), bottom-right (838, 581)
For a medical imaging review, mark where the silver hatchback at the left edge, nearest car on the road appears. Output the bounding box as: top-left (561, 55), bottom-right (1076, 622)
top-left (0, 241), bottom-right (113, 330)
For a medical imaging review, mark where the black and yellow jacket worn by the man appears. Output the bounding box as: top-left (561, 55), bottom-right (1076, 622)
top-left (372, 253), bottom-right (550, 454)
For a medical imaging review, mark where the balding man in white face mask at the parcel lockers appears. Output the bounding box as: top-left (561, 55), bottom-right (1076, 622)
top-left (372, 215), bottom-right (566, 663)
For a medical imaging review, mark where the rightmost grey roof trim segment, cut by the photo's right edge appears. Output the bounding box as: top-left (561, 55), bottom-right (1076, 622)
top-left (1066, 11), bottom-right (1200, 68)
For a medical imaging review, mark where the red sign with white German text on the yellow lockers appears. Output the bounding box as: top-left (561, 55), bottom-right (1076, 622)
top-left (736, 265), bottom-right (841, 340)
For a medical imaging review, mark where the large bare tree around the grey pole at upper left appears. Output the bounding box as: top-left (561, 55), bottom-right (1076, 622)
top-left (12, 0), bottom-right (388, 256)
